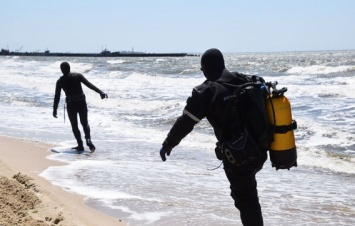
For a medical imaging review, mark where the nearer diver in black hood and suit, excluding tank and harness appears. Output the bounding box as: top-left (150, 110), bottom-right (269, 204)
top-left (160, 49), bottom-right (267, 226)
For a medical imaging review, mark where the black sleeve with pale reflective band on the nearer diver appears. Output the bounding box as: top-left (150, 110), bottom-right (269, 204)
top-left (163, 89), bottom-right (210, 150)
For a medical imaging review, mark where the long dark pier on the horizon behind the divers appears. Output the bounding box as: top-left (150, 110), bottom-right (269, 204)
top-left (0, 49), bottom-right (199, 57)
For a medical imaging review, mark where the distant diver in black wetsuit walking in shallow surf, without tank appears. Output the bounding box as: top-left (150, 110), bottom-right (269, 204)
top-left (53, 62), bottom-right (108, 151)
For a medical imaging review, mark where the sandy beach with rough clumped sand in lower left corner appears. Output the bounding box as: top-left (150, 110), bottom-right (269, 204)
top-left (0, 136), bottom-right (125, 226)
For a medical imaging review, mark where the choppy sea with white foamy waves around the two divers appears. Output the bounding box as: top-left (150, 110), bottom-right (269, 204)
top-left (0, 50), bottom-right (355, 226)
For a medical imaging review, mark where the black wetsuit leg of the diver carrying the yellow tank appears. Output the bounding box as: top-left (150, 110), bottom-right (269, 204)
top-left (224, 164), bottom-right (264, 226)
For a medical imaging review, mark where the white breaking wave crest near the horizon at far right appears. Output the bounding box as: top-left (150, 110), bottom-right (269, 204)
top-left (286, 65), bottom-right (355, 75)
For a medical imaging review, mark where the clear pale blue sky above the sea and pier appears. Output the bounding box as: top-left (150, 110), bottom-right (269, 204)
top-left (0, 0), bottom-right (355, 53)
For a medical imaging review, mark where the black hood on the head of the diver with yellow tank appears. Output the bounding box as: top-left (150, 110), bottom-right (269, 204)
top-left (201, 49), bottom-right (225, 81)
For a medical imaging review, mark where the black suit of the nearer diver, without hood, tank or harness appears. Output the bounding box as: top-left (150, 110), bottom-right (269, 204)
top-left (163, 69), bottom-right (266, 226)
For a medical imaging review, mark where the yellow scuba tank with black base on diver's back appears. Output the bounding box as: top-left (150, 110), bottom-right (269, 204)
top-left (266, 82), bottom-right (297, 170)
